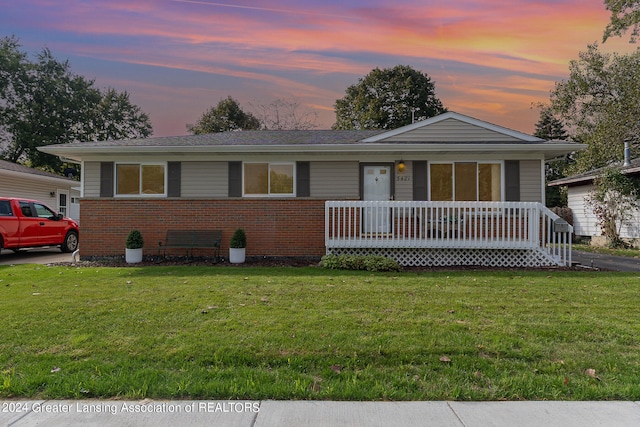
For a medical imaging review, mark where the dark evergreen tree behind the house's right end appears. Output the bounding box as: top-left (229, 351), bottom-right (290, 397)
top-left (533, 106), bottom-right (569, 207)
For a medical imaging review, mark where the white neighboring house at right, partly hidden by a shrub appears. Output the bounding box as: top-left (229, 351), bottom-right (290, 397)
top-left (549, 159), bottom-right (640, 244)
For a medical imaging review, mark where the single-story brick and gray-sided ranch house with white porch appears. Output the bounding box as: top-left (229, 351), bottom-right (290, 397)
top-left (41, 112), bottom-right (584, 266)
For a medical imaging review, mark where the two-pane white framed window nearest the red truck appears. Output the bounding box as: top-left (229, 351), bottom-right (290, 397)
top-left (115, 163), bottom-right (167, 196)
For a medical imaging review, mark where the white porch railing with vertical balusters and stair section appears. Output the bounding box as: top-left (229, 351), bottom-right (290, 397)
top-left (325, 201), bottom-right (573, 266)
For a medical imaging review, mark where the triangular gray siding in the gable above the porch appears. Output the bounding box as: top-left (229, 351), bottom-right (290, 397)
top-left (380, 119), bottom-right (522, 142)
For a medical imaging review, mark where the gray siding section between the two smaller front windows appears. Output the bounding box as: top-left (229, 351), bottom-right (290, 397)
top-left (180, 162), bottom-right (229, 198)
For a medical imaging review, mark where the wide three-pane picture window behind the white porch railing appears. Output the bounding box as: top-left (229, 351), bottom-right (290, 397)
top-left (429, 162), bottom-right (502, 202)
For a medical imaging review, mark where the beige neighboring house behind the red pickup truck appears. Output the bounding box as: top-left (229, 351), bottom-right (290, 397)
top-left (0, 160), bottom-right (80, 220)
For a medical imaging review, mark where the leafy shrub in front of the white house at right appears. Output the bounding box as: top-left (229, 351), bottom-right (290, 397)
top-left (585, 168), bottom-right (640, 247)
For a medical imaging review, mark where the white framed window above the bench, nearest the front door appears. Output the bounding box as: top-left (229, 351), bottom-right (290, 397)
top-left (242, 162), bottom-right (296, 196)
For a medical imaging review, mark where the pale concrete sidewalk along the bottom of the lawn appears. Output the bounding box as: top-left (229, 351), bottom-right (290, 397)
top-left (0, 399), bottom-right (640, 427)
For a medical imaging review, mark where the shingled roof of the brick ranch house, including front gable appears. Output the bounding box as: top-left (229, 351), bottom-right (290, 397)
top-left (38, 112), bottom-right (584, 162)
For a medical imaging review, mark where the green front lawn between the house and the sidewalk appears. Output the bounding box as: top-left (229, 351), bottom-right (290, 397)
top-left (0, 265), bottom-right (640, 400)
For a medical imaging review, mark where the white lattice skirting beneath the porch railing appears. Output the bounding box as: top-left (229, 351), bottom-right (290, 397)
top-left (327, 248), bottom-right (558, 267)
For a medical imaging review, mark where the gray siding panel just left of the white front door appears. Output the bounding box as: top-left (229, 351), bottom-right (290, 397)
top-left (311, 162), bottom-right (360, 199)
